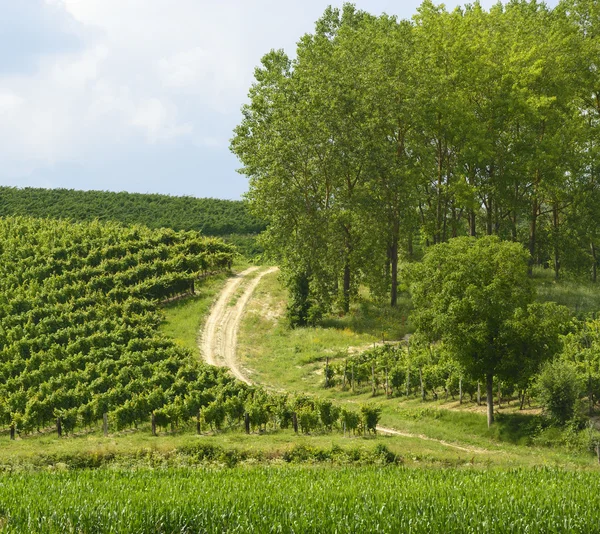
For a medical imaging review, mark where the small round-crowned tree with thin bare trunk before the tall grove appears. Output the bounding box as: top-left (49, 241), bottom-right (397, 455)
top-left (411, 236), bottom-right (534, 425)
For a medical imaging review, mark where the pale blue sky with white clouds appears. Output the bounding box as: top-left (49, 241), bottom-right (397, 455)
top-left (0, 0), bottom-right (557, 199)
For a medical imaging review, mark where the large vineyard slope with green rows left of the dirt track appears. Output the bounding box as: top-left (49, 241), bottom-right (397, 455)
top-left (0, 218), bottom-right (245, 437)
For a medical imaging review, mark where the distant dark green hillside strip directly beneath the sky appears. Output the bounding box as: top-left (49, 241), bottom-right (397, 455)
top-left (0, 187), bottom-right (265, 236)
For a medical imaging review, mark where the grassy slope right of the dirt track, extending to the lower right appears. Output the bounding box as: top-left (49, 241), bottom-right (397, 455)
top-left (239, 274), bottom-right (595, 465)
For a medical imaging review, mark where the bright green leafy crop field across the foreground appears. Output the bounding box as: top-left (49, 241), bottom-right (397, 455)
top-left (0, 466), bottom-right (600, 534)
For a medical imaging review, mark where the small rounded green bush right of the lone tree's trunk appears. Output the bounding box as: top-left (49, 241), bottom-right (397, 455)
top-left (536, 359), bottom-right (582, 425)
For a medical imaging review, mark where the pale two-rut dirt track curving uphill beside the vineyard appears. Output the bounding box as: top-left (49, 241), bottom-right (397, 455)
top-left (200, 267), bottom-right (277, 384)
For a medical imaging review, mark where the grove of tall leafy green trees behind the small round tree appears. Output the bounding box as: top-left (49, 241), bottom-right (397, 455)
top-left (231, 0), bottom-right (600, 319)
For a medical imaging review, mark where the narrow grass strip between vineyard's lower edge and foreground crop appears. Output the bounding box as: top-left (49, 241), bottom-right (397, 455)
top-left (0, 425), bottom-right (516, 471)
